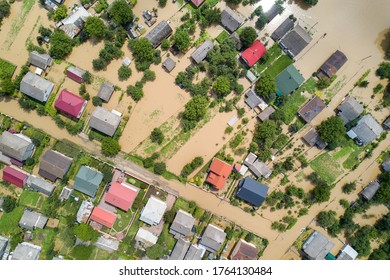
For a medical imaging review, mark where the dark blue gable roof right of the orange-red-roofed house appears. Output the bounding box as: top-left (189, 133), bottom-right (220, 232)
top-left (236, 177), bottom-right (268, 207)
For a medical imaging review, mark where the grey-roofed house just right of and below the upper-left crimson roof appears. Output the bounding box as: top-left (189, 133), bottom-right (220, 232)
top-left (89, 106), bottom-right (121, 136)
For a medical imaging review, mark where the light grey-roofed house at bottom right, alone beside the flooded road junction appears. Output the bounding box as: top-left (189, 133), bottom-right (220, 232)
top-left (302, 231), bottom-right (334, 260)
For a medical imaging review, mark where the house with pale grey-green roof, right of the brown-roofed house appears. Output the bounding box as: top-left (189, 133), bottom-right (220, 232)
top-left (73, 166), bottom-right (103, 197)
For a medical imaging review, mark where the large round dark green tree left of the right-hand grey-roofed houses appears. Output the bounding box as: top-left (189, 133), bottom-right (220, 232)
top-left (317, 116), bottom-right (346, 147)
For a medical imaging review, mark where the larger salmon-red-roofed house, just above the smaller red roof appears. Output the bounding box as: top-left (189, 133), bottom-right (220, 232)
top-left (104, 182), bottom-right (139, 211)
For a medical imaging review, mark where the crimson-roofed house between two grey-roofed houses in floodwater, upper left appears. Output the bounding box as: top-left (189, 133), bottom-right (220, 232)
top-left (54, 89), bottom-right (87, 119)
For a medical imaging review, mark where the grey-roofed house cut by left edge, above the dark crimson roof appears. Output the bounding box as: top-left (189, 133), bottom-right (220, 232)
top-left (0, 131), bottom-right (34, 162)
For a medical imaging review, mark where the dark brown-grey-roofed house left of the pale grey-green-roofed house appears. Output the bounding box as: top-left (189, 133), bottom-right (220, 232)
top-left (38, 150), bottom-right (73, 182)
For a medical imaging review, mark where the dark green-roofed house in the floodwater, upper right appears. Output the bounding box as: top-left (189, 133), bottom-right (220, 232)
top-left (276, 64), bottom-right (305, 96)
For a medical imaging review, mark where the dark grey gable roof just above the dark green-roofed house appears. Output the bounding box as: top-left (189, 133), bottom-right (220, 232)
top-left (280, 24), bottom-right (312, 57)
